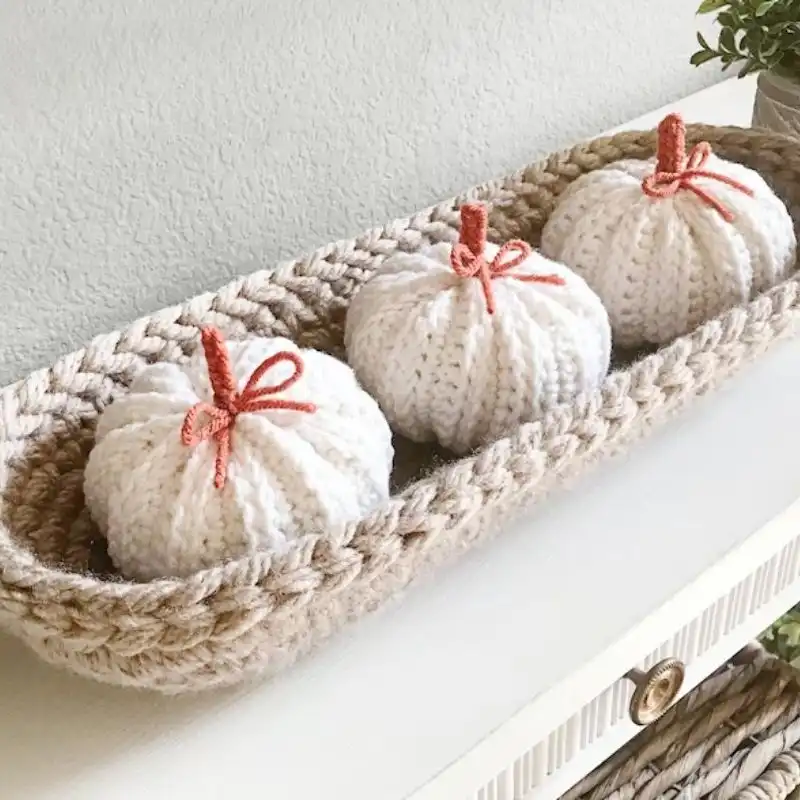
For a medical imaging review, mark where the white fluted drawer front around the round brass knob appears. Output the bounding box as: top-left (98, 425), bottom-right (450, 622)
top-left (412, 512), bottom-right (800, 800)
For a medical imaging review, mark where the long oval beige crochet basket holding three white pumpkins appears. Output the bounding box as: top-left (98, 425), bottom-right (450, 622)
top-left (0, 126), bottom-right (800, 692)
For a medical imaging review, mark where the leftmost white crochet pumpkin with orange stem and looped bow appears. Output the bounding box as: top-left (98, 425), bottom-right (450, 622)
top-left (84, 328), bottom-right (393, 580)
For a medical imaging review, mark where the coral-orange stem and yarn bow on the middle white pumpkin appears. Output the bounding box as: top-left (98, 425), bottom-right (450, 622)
top-left (450, 203), bottom-right (565, 314)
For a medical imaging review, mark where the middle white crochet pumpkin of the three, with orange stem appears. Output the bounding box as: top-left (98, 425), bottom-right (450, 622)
top-left (345, 204), bottom-right (611, 452)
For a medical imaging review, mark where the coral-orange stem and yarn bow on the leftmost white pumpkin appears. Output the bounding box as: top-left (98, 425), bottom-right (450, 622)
top-left (181, 327), bottom-right (317, 489)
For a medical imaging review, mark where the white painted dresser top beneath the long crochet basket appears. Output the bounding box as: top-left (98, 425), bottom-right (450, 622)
top-left (0, 80), bottom-right (788, 800)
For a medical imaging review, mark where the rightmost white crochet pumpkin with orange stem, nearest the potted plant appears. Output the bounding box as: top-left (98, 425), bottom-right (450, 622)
top-left (542, 114), bottom-right (796, 347)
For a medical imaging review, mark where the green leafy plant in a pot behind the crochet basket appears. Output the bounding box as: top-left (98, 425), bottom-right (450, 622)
top-left (691, 0), bottom-right (800, 136)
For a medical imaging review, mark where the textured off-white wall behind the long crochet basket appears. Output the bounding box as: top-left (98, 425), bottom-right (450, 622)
top-left (0, 0), bottom-right (718, 383)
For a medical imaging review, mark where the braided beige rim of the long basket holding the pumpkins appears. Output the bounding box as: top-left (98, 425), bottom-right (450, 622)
top-left (0, 124), bottom-right (800, 688)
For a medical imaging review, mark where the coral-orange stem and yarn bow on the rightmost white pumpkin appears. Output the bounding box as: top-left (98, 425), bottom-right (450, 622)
top-left (642, 114), bottom-right (753, 222)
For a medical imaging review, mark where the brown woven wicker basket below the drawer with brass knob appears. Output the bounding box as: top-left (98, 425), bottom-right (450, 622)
top-left (561, 650), bottom-right (800, 800)
